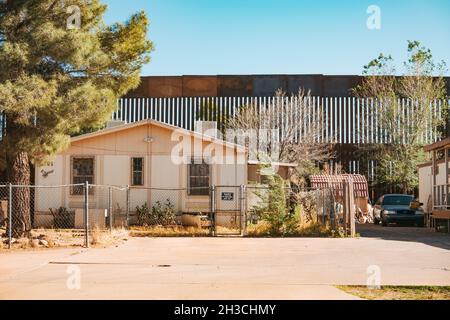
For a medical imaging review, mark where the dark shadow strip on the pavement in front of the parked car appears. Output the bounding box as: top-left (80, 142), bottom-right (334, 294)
top-left (356, 224), bottom-right (450, 250)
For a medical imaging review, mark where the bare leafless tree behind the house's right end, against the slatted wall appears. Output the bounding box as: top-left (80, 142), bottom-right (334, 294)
top-left (226, 89), bottom-right (333, 184)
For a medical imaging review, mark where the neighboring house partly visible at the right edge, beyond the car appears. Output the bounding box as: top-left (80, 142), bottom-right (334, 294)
top-left (419, 137), bottom-right (450, 232)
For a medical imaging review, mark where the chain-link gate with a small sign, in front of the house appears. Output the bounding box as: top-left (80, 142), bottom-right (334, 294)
top-left (210, 185), bottom-right (246, 236)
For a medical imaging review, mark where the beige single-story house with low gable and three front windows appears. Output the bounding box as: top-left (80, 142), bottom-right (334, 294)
top-left (34, 120), bottom-right (248, 227)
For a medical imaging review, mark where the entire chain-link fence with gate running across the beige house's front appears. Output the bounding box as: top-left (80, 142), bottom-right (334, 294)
top-left (0, 182), bottom-right (342, 247)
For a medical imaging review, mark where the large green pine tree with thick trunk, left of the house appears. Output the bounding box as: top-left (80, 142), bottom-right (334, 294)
top-left (0, 0), bottom-right (153, 236)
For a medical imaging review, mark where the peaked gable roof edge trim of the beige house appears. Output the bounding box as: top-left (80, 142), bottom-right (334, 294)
top-left (70, 119), bottom-right (246, 152)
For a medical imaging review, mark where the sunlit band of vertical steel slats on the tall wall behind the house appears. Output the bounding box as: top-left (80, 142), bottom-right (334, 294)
top-left (111, 96), bottom-right (450, 144)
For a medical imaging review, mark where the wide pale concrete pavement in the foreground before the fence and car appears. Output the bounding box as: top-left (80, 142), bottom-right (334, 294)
top-left (0, 226), bottom-right (450, 299)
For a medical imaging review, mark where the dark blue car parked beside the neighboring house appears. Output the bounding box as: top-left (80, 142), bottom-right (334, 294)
top-left (373, 194), bottom-right (424, 227)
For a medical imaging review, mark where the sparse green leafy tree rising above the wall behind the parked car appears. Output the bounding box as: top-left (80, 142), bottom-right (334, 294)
top-left (354, 41), bottom-right (447, 193)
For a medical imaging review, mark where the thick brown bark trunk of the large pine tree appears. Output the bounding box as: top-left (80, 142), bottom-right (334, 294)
top-left (8, 152), bottom-right (31, 238)
